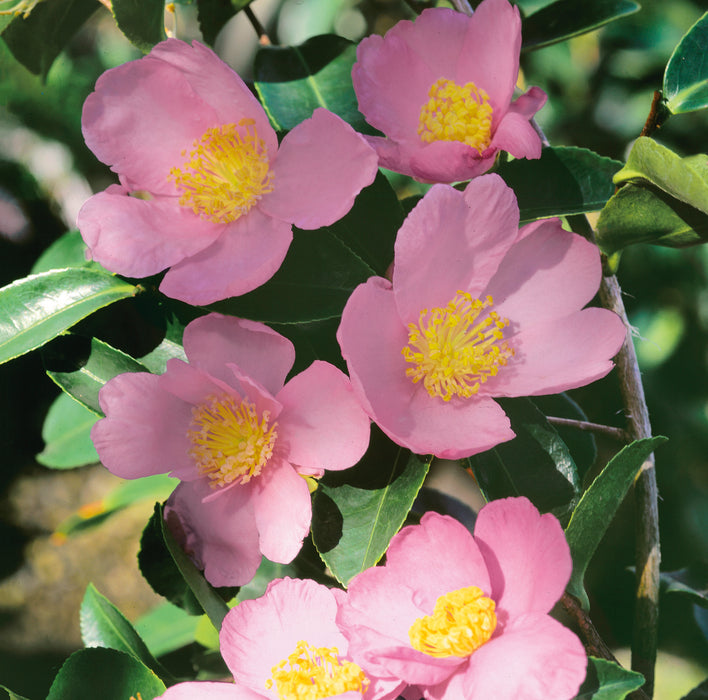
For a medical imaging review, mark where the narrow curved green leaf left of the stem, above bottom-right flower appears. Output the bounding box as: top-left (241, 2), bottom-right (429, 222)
top-left (565, 436), bottom-right (667, 610)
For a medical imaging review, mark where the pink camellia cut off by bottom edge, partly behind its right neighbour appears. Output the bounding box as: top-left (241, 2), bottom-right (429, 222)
top-left (160, 578), bottom-right (404, 700)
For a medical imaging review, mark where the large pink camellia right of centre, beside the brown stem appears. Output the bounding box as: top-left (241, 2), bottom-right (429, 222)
top-left (337, 175), bottom-right (625, 459)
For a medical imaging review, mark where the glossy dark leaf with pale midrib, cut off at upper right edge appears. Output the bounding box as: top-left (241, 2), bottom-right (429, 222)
top-left (663, 12), bottom-right (708, 114)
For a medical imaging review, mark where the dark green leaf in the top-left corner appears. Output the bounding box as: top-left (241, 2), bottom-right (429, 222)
top-left (2, 0), bottom-right (99, 77)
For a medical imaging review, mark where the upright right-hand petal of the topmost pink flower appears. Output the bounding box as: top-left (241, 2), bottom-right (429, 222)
top-left (455, 0), bottom-right (521, 121)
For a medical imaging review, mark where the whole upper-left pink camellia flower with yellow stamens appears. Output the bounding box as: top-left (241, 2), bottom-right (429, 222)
top-left (78, 39), bottom-right (377, 304)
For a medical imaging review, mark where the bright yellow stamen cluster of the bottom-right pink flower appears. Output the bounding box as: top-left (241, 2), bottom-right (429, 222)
top-left (408, 586), bottom-right (497, 658)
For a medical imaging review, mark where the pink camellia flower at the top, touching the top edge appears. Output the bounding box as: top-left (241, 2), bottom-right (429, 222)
top-left (352, 0), bottom-right (546, 183)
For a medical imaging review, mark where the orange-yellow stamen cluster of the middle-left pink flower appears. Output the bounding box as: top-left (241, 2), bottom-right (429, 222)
top-left (187, 395), bottom-right (278, 489)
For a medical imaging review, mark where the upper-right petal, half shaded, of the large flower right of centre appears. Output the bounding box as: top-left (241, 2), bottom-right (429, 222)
top-left (485, 219), bottom-right (602, 332)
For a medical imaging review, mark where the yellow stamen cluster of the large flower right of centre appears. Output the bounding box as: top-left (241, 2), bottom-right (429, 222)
top-left (401, 291), bottom-right (514, 401)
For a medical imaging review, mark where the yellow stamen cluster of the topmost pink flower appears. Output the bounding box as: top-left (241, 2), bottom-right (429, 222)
top-left (418, 78), bottom-right (492, 153)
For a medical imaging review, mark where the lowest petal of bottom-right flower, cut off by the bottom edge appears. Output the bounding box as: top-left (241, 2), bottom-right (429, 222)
top-left (426, 614), bottom-right (587, 700)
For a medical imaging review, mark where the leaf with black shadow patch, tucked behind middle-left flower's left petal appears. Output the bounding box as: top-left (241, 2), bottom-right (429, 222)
top-left (43, 335), bottom-right (147, 416)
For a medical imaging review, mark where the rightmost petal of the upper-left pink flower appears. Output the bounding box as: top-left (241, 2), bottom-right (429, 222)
top-left (259, 108), bottom-right (378, 229)
